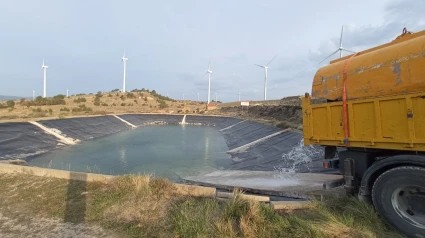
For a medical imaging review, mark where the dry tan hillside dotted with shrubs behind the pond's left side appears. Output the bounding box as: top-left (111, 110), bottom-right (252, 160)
top-left (0, 90), bottom-right (206, 121)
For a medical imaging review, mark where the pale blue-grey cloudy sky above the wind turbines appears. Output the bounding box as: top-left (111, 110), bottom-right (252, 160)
top-left (0, 0), bottom-right (425, 101)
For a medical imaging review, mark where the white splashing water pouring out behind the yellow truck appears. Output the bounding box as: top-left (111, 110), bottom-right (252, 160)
top-left (275, 139), bottom-right (325, 178)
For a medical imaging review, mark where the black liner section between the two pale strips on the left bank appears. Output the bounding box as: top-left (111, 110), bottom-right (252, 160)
top-left (39, 116), bottom-right (131, 141)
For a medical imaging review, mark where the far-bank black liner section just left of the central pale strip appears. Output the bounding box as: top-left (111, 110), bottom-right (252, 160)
top-left (117, 114), bottom-right (183, 126)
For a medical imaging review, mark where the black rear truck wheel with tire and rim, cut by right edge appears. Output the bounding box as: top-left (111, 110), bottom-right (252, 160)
top-left (372, 166), bottom-right (425, 238)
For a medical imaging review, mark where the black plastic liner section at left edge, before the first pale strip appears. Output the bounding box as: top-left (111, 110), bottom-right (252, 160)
top-left (0, 122), bottom-right (63, 160)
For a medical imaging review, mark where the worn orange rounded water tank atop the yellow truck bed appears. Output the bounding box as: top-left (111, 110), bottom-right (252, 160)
top-left (311, 30), bottom-right (425, 100)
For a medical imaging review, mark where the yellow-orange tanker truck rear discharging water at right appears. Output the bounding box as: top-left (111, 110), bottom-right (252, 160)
top-left (302, 29), bottom-right (425, 237)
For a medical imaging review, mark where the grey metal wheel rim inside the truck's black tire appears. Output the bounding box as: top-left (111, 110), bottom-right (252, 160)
top-left (391, 186), bottom-right (425, 229)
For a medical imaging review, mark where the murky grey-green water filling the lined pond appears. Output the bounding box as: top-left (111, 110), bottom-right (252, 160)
top-left (28, 125), bottom-right (231, 181)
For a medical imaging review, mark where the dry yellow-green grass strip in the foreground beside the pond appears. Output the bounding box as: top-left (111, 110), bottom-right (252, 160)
top-left (0, 174), bottom-right (401, 238)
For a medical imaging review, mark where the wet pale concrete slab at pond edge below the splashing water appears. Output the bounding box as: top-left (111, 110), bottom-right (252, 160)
top-left (183, 170), bottom-right (343, 199)
